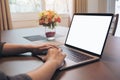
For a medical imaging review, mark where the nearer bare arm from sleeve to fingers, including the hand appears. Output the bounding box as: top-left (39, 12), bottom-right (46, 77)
top-left (27, 47), bottom-right (66, 80)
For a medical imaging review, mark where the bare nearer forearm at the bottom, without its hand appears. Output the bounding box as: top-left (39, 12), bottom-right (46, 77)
top-left (28, 61), bottom-right (58, 80)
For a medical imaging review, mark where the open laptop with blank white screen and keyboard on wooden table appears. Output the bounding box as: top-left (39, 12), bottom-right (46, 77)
top-left (60, 13), bottom-right (113, 70)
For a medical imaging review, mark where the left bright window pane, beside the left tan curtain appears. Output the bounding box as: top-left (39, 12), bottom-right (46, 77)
top-left (9, 0), bottom-right (42, 13)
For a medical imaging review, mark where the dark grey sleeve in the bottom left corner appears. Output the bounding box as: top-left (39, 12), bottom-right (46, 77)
top-left (0, 72), bottom-right (32, 80)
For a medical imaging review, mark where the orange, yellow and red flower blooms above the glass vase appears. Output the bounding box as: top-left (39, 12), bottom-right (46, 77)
top-left (39, 10), bottom-right (61, 28)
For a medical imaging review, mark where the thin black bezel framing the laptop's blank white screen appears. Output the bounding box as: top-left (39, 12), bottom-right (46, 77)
top-left (64, 13), bottom-right (114, 58)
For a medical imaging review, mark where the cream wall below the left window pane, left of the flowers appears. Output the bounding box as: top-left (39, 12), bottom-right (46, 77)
top-left (12, 13), bottom-right (38, 29)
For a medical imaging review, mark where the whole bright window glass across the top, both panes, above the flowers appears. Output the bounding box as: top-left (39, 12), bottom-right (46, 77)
top-left (9, 0), bottom-right (68, 13)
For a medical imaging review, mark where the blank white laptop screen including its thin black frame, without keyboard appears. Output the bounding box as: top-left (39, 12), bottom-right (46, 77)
top-left (65, 14), bottom-right (113, 55)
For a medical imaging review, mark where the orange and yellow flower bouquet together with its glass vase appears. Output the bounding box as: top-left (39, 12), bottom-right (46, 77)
top-left (39, 10), bottom-right (61, 40)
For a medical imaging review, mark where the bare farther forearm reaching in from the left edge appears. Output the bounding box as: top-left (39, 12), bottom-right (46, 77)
top-left (2, 43), bottom-right (32, 55)
